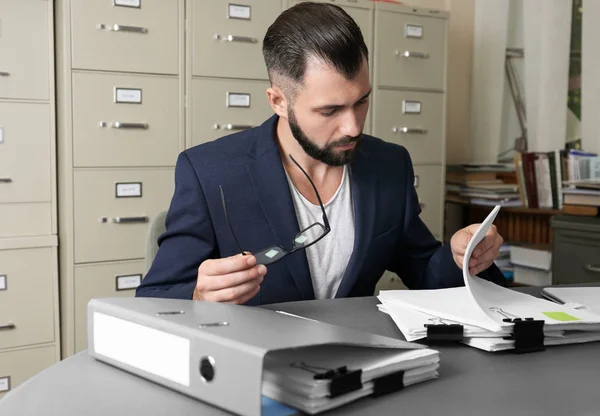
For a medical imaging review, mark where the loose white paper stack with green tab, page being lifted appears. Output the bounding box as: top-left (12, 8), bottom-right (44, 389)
top-left (378, 206), bottom-right (600, 351)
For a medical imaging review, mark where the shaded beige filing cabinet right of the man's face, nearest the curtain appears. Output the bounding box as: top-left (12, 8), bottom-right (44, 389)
top-left (371, 2), bottom-right (448, 237)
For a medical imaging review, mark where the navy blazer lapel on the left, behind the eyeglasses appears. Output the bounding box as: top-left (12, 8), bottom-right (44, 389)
top-left (246, 116), bottom-right (315, 300)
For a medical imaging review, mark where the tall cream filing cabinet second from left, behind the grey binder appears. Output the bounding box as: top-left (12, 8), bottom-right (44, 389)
top-left (56, 0), bottom-right (185, 357)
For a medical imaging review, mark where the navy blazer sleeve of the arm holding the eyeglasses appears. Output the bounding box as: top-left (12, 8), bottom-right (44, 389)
top-left (136, 152), bottom-right (217, 299)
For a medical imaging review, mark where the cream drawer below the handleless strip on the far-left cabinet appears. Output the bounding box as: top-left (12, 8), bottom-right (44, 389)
top-left (0, 247), bottom-right (56, 349)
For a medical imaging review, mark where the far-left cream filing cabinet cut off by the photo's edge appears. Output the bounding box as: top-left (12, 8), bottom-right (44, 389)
top-left (0, 0), bottom-right (60, 398)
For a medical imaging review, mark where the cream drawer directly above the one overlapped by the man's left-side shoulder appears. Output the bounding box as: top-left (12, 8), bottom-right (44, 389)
top-left (73, 73), bottom-right (181, 167)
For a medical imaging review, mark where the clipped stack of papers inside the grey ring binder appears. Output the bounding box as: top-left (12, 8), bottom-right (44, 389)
top-left (262, 345), bottom-right (439, 414)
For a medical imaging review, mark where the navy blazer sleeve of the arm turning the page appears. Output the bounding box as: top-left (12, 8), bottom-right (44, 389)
top-left (389, 149), bottom-right (506, 289)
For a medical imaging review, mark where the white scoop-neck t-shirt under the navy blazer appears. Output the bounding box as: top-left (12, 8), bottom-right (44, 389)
top-left (286, 166), bottom-right (354, 299)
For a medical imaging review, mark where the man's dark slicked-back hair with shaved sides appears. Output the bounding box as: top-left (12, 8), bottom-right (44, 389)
top-left (263, 2), bottom-right (369, 94)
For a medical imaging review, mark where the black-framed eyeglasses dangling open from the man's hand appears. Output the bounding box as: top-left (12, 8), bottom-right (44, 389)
top-left (219, 155), bottom-right (331, 265)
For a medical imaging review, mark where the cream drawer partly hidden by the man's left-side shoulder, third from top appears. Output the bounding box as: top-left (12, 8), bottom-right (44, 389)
top-left (74, 168), bottom-right (174, 263)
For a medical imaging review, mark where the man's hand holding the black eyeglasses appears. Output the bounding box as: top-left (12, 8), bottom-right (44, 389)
top-left (193, 254), bottom-right (267, 304)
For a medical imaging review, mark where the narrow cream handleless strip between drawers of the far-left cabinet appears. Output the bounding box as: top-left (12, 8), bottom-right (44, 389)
top-left (0, 202), bottom-right (52, 238)
